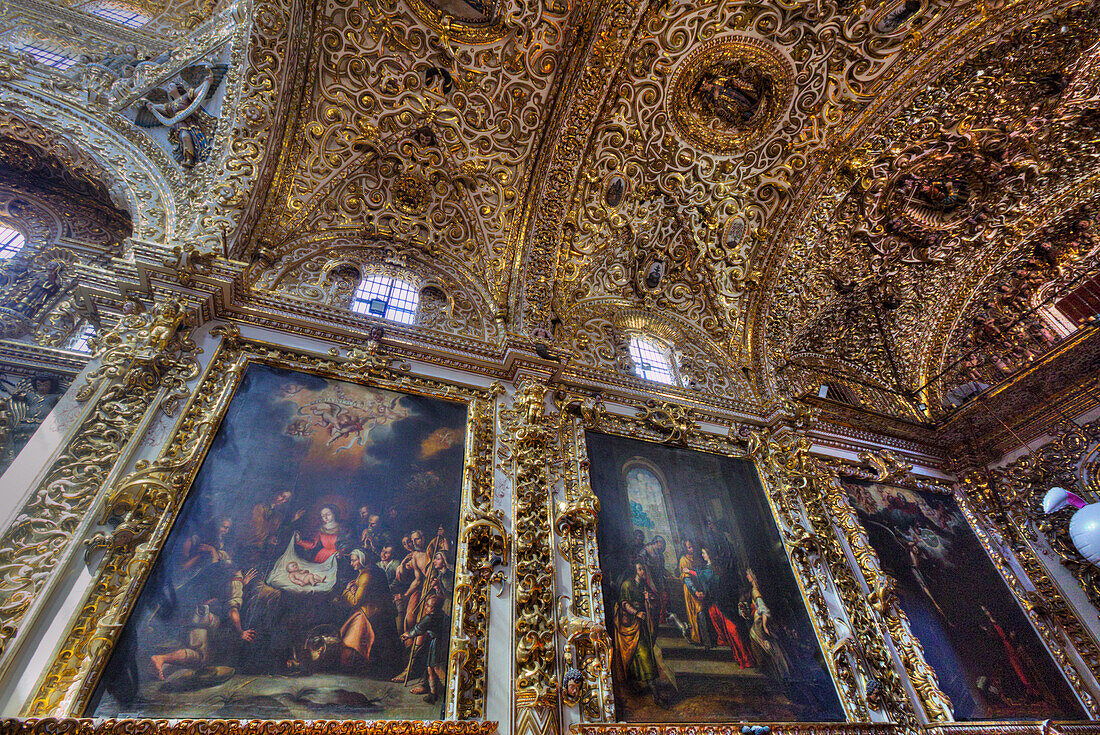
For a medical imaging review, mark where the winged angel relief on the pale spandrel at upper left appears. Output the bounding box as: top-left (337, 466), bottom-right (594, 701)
top-left (134, 64), bottom-right (229, 168)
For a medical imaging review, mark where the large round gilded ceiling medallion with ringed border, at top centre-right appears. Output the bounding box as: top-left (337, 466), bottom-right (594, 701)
top-left (669, 36), bottom-right (794, 154)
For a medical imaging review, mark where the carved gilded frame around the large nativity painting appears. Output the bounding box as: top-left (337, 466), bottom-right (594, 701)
top-left (24, 332), bottom-right (503, 718)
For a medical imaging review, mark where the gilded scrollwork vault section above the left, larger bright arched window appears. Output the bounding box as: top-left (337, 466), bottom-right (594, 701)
top-left (249, 0), bottom-right (567, 303)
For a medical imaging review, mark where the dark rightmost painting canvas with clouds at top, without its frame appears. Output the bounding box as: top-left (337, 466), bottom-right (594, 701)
top-left (845, 481), bottom-right (1085, 720)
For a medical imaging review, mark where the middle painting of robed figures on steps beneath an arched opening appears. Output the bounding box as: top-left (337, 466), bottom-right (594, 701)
top-left (586, 434), bottom-right (845, 722)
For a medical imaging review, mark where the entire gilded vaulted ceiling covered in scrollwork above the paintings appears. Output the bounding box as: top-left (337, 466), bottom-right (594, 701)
top-left (239, 0), bottom-right (1100, 421)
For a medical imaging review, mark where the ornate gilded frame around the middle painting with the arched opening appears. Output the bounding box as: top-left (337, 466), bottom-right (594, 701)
top-left (554, 395), bottom-right (880, 728)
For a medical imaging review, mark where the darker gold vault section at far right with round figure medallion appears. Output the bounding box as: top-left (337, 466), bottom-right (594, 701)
top-left (757, 3), bottom-right (1100, 419)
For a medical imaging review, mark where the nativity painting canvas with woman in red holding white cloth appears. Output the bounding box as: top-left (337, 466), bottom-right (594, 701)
top-left (89, 364), bottom-right (466, 720)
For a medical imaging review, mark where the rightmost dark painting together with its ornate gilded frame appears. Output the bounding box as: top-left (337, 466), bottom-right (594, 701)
top-left (826, 468), bottom-right (1097, 721)
